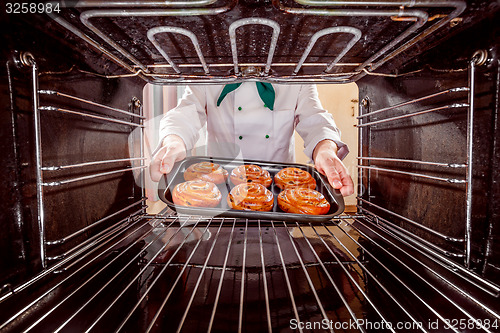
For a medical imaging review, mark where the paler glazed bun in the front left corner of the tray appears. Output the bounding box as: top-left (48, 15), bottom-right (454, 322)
top-left (172, 179), bottom-right (222, 207)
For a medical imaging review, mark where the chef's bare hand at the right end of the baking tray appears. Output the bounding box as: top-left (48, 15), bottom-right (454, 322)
top-left (313, 140), bottom-right (354, 197)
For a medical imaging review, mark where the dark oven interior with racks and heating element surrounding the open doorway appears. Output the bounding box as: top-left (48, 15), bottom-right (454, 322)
top-left (0, 0), bottom-right (500, 332)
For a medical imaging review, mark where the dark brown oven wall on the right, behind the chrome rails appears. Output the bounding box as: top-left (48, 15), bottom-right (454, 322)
top-left (358, 14), bottom-right (500, 281)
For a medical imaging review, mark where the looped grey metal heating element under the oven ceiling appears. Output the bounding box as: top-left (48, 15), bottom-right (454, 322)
top-left (47, 0), bottom-right (466, 84)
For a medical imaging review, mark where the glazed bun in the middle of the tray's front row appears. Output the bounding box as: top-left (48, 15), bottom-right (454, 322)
top-left (227, 183), bottom-right (274, 212)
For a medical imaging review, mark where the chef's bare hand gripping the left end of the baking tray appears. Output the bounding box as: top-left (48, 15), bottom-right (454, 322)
top-left (149, 134), bottom-right (186, 182)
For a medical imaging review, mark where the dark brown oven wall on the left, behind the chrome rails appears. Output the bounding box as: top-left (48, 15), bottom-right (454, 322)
top-left (0, 14), bottom-right (144, 288)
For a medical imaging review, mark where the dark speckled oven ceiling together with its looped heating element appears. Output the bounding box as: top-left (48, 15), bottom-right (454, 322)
top-left (51, 0), bottom-right (493, 84)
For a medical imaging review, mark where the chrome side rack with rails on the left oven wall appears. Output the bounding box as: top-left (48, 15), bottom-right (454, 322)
top-left (27, 54), bottom-right (147, 269)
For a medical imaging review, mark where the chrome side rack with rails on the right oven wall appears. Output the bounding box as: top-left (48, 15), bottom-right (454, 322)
top-left (356, 57), bottom-right (477, 268)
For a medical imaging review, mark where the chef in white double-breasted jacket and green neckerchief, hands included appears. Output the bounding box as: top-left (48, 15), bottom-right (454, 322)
top-left (150, 81), bottom-right (354, 196)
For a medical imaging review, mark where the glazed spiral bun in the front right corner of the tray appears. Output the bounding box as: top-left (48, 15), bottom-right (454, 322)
top-left (278, 187), bottom-right (330, 215)
